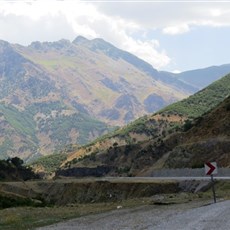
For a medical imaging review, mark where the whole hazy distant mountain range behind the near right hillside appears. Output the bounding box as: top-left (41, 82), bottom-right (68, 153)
top-left (0, 36), bottom-right (230, 160)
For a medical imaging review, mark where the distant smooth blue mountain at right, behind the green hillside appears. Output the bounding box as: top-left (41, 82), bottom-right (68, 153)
top-left (162, 64), bottom-right (230, 90)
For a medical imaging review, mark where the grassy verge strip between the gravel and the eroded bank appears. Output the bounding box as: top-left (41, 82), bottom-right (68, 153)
top-left (0, 181), bottom-right (230, 230)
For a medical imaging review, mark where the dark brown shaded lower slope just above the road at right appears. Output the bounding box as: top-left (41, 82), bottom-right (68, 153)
top-left (57, 94), bottom-right (230, 176)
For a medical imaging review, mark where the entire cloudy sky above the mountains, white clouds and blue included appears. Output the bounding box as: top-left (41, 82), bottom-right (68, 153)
top-left (0, 0), bottom-right (230, 71)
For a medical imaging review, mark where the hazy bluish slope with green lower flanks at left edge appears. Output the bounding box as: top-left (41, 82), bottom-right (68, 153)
top-left (0, 41), bottom-right (108, 159)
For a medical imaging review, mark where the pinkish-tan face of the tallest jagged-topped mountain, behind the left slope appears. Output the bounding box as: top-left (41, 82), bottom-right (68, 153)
top-left (16, 37), bottom-right (191, 126)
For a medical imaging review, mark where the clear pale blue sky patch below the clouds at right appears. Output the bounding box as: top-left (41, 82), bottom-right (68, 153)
top-left (149, 26), bottom-right (230, 71)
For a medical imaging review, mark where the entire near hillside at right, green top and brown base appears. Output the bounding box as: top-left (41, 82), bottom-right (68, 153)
top-left (54, 75), bottom-right (230, 175)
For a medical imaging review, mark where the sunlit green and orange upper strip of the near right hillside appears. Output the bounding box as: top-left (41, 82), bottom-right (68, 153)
top-left (54, 75), bottom-right (230, 171)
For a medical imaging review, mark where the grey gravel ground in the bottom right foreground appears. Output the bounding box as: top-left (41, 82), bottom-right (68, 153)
top-left (37, 200), bottom-right (230, 230)
